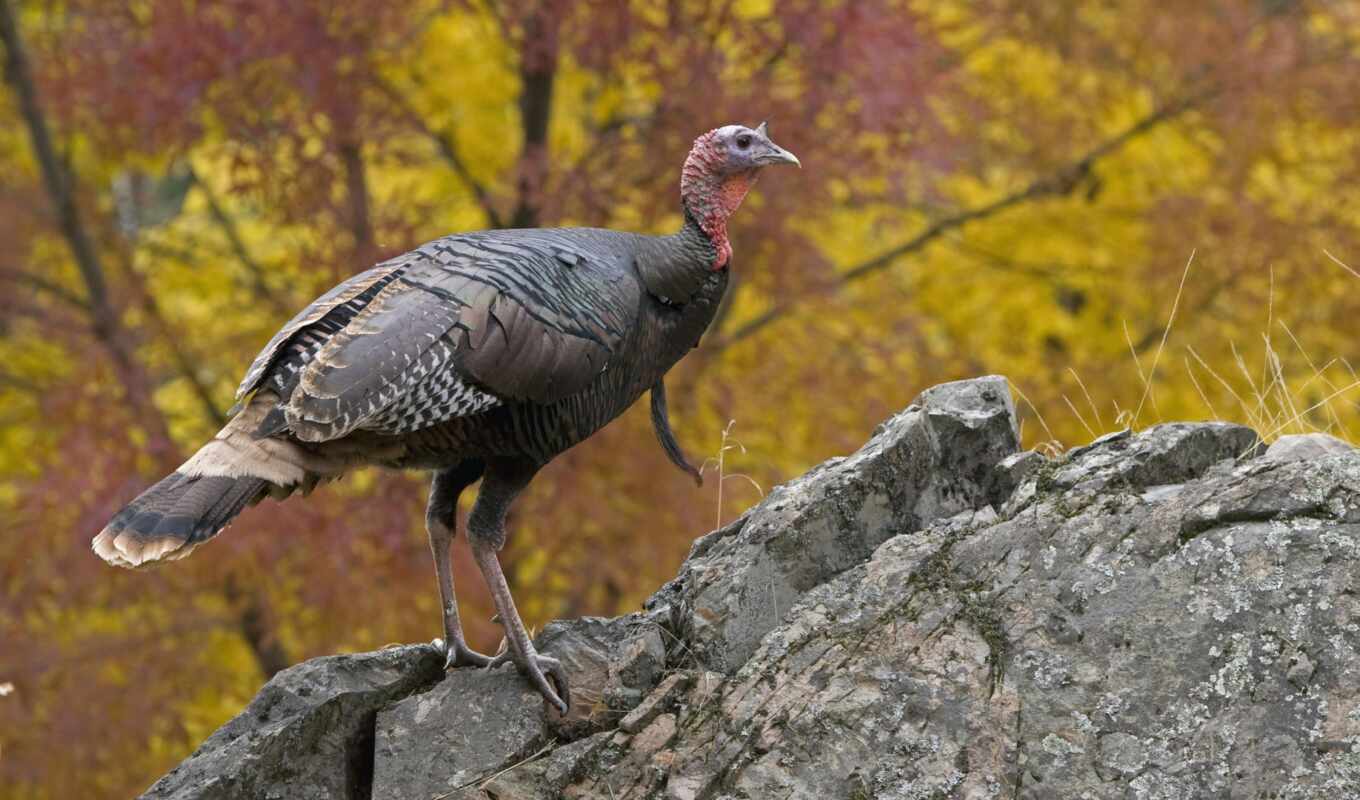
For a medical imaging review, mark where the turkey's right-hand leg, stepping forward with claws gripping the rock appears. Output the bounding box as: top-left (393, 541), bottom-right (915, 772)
top-left (468, 460), bottom-right (571, 714)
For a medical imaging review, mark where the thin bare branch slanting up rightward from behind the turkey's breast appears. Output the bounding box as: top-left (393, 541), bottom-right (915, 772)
top-left (707, 88), bottom-right (1217, 351)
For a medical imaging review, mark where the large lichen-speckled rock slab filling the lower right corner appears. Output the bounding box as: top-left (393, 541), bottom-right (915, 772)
top-left (560, 426), bottom-right (1360, 799)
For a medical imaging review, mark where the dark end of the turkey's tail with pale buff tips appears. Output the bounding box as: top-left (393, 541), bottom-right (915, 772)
top-left (92, 472), bottom-right (269, 567)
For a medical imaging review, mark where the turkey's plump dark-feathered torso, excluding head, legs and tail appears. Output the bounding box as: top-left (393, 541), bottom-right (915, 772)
top-left (238, 224), bottom-right (728, 476)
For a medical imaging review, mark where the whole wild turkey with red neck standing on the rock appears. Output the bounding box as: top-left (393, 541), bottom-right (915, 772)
top-left (92, 122), bottom-right (801, 714)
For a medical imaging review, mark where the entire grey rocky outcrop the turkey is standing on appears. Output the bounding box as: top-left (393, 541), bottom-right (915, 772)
top-left (146, 377), bottom-right (1360, 800)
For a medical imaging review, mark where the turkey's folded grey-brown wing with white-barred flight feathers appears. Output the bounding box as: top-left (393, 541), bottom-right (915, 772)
top-left (283, 230), bottom-right (641, 441)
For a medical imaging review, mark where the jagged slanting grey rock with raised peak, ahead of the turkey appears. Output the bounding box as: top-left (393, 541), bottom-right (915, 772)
top-left (647, 376), bottom-right (1019, 673)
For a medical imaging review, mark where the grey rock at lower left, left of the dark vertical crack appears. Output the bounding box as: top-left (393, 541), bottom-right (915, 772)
top-left (143, 645), bottom-right (443, 800)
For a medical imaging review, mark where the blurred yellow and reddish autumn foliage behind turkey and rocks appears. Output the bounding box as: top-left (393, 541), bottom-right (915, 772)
top-left (0, 0), bottom-right (1360, 797)
